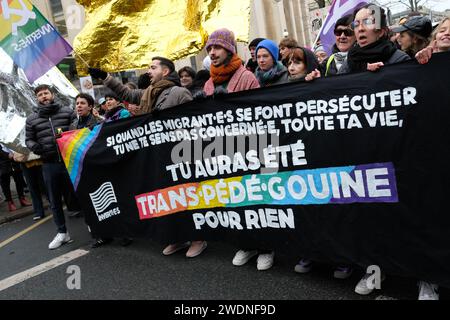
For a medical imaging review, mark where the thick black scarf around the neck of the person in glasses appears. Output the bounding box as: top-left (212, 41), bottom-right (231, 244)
top-left (347, 39), bottom-right (397, 72)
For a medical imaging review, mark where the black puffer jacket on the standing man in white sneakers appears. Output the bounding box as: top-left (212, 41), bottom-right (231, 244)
top-left (25, 102), bottom-right (77, 162)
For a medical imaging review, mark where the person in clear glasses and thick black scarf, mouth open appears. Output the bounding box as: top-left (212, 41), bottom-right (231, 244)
top-left (338, 4), bottom-right (410, 74)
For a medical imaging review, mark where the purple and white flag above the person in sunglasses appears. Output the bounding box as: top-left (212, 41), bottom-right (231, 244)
top-left (313, 0), bottom-right (368, 55)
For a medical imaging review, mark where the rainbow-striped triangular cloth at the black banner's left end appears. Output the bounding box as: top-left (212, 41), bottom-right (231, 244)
top-left (57, 124), bottom-right (102, 190)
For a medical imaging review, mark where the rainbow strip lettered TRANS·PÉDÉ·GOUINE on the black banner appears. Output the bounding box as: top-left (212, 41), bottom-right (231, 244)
top-left (135, 162), bottom-right (398, 220)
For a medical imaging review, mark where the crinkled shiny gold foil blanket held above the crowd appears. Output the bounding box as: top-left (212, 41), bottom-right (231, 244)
top-left (74, 0), bottom-right (250, 75)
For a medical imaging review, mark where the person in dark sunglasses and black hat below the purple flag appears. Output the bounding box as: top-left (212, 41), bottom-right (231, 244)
top-left (319, 14), bottom-right (356, 77)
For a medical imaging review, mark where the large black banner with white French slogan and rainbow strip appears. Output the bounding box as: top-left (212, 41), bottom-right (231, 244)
top-left (63, 53), bottom-right (450, 287)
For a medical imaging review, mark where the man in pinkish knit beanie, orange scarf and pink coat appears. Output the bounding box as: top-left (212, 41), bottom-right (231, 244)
top-left (203, 29), bottom-right (259, 96)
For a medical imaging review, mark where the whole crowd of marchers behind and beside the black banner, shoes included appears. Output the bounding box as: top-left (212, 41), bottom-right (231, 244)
top-left (9, 1), bottom-right (450, 299)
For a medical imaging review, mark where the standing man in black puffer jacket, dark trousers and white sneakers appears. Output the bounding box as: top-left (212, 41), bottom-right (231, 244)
top-left (25, 85), bottom-right (76, 250)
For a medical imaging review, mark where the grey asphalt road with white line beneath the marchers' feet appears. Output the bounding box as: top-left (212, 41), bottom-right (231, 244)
top-left (0, 210), bottom-right (450, 301)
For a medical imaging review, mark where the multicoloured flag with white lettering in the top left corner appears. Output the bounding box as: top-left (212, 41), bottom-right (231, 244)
top-left (0, 0), bottom-right (73, 83)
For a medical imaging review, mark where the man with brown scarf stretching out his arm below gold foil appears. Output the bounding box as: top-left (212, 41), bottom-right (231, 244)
top-left (89, 57), bottom-right (192, 114)
